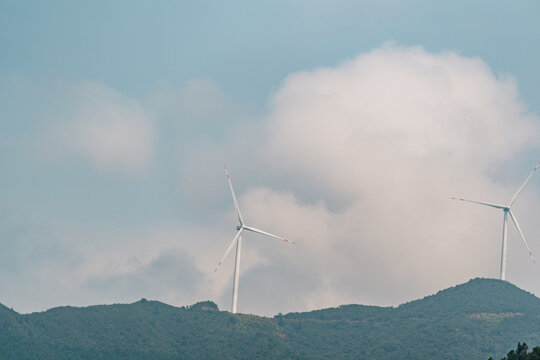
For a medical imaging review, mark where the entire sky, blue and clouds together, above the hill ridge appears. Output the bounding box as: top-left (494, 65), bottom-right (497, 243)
top-left (0, 0), bottom-right (540, 315)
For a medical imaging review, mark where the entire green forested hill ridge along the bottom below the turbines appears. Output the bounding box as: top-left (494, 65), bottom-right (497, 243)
top-left (0, 279), bottom-right (540, 360)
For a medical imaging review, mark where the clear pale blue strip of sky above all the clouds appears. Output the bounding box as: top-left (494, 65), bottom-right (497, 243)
top-left (4, 1), bottom-right (540, 110)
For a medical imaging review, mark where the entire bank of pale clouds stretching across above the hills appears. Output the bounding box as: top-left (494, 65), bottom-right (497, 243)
top-left (4, 44), bottom-right (540, 315)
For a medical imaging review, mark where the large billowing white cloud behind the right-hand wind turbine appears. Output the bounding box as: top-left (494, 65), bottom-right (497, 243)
top-left (196, 44), bottom-right (540, 313)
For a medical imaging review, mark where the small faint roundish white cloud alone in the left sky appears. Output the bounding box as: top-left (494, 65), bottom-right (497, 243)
top-left (47, 82), bottom-right (156, 175)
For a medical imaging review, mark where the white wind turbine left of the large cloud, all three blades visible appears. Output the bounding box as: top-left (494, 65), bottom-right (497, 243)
top-left (214, 167), bottom-right (295, 314)
